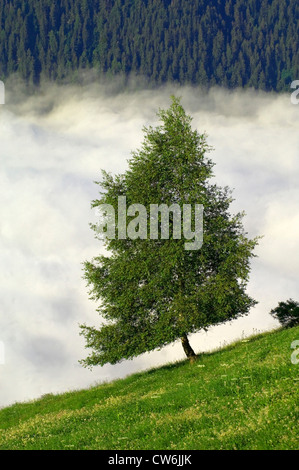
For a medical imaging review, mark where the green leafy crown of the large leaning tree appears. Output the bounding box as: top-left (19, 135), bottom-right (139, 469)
top-left (81, 98), bottom-right (257, 366)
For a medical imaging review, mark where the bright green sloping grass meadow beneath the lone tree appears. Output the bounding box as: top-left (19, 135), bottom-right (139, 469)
top-left (0, 327), bottom-right (299, 450)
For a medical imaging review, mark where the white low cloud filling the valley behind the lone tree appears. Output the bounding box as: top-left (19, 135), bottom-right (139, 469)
top-left (0, 82), bottom-right (299, 406)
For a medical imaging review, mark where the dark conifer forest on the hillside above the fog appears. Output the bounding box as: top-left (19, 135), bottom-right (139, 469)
top-left (0, 0), bottom-right (299, 91)
